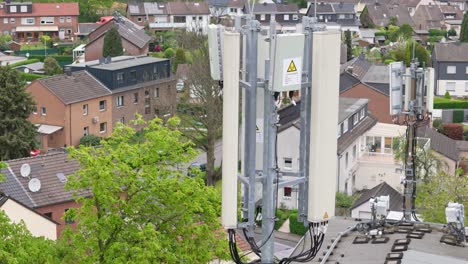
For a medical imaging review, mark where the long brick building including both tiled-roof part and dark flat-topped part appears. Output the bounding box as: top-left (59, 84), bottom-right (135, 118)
top-left (26, 56), bottom-right (177, 151)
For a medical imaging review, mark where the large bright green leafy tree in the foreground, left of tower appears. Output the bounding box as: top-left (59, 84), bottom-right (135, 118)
top-left (60, 117), bottom-right (227, 263)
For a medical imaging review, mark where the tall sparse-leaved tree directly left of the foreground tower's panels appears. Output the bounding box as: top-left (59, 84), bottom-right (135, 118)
top-left (177, 36), bottom-right (223, 185)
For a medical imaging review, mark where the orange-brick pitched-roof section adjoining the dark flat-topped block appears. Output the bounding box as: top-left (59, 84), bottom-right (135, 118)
top-left (26, 71), bottom-right (112, 152)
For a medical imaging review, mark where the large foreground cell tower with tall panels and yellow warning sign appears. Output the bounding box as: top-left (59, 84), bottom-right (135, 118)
top-left (208, 12), bottom-right (341, 263)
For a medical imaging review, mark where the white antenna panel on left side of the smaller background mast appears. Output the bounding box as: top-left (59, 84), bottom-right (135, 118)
top-left (388, 61), bottom-right (405, 115)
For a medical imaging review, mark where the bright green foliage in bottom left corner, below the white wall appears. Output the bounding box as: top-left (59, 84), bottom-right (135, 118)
top-left (0, 210), bottom-right (60, 263)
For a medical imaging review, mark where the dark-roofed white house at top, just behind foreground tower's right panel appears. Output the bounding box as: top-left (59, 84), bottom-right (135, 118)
top-left (307, 2), bottom-right (361, 32)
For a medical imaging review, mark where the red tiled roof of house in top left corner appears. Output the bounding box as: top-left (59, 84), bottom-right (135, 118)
top-left (0, 3), bottom-right (80, 17)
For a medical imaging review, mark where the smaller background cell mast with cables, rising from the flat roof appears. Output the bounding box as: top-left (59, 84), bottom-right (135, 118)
top-left (389, 59), bottom-right (434, 221)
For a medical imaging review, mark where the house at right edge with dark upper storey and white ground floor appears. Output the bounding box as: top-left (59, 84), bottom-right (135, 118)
top-left (432, 43), bottom-right (468, 97)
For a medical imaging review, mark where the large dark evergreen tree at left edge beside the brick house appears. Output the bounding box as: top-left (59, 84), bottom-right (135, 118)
top-left (0, 66), bottom-right (38, 160)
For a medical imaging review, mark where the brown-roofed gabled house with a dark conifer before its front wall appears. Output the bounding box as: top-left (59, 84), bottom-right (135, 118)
top-left (85, 15), bottom-right (151, 61)
